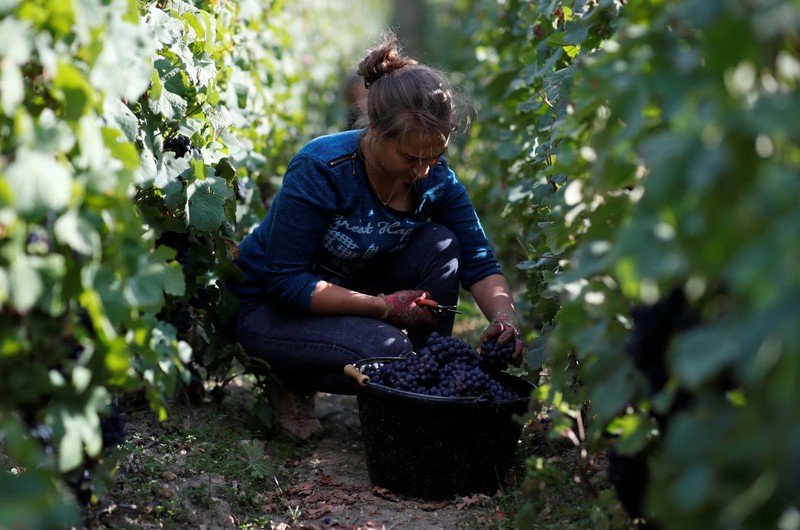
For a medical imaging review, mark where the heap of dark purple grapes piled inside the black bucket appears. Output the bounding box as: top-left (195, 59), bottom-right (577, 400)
top-left (364, 333), bottom-right (518, 402)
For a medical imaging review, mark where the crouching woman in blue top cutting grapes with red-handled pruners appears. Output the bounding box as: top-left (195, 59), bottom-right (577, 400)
top-left (230, 35), bottom-right (522, 440)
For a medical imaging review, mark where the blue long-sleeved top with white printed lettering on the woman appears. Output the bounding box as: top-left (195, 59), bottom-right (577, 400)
top-left (232, 130), bottom-right (501, 310)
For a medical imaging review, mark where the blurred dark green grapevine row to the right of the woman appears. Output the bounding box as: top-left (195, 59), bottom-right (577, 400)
top-left (437, 0), bottom-right (800, 529)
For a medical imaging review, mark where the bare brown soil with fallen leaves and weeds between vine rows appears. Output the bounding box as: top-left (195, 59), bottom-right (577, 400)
top-left (86, 380), bottom-right (520, 530)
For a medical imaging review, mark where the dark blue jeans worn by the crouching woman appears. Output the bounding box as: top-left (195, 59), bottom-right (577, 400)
top-left (234, 223), bottom-right (461, 395)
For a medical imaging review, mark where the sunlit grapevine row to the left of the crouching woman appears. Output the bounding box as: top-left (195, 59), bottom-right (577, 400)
top-left (0, 0), bottom-right (388, 528)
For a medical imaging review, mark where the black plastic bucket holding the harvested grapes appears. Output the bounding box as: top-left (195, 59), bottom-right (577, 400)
top-left (356, 359), bottom-right (534, 500)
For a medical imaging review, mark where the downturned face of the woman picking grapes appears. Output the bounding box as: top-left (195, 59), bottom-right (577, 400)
top-left (375, 131), bottom-right (449, 184)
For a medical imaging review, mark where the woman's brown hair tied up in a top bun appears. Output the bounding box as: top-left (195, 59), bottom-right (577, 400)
top-left (356, 33), bottom-right (469, 139)
